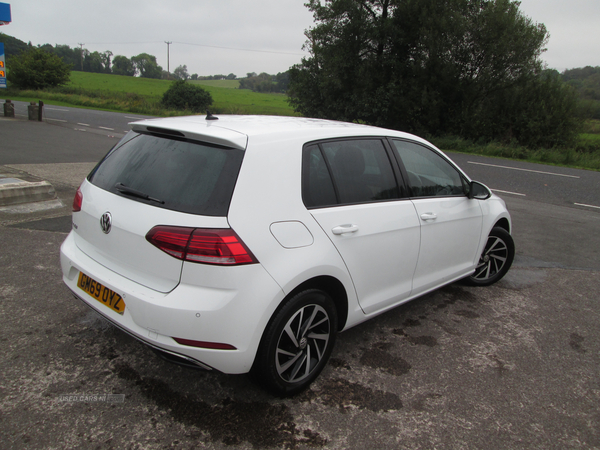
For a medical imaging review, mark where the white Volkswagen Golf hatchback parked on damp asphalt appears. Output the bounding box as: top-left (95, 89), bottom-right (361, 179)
top-left (61, 115), bottom-right (514, 395)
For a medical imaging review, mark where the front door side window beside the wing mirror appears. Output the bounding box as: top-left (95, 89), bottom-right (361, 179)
top-left (393, 140), bottom-right (465, 197)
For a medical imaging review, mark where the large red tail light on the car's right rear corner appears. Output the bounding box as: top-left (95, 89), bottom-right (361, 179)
top-left (146, 225), bottom-right (258, 266)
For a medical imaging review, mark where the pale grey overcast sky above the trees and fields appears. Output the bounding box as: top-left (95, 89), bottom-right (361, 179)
top-left (0, 0), bottom-right (600, 76)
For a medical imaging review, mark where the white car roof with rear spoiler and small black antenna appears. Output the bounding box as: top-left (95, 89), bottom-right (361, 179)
top-left (131, 114), bottom-right (431, 150)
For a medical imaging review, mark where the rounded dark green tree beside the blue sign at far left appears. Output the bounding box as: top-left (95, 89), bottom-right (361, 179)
top-left (7, 48), bottom-right (71, 90)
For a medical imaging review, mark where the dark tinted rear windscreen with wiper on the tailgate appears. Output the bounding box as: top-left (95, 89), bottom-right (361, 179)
top-left (88, 133), bottom-right (244, 216)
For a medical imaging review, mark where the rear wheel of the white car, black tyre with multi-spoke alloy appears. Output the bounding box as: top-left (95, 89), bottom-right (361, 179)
top-left (250, 289), bottom-right (337, 396)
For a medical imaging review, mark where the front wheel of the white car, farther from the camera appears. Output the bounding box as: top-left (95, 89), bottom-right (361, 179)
top-left (465, 227), bottom-right (515, 286)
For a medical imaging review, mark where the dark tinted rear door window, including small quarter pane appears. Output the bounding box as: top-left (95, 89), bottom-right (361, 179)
top-left (302, 139), bottom-right (400, 207)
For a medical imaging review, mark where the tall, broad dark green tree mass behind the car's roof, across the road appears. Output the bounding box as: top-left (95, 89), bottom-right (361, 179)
top-left (288, 0), bottom-right (574, 148)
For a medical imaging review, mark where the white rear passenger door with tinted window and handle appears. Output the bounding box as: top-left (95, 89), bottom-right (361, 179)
top-left (303, 138), bottom-right (420, 314)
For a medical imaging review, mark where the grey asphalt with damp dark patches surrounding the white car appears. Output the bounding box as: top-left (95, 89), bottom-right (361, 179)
top-left (0, 119), bottom-right (600, 449)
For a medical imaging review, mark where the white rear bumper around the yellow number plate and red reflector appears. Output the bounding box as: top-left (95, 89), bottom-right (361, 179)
top-left (60, 230), bottom-right (283, 374)
